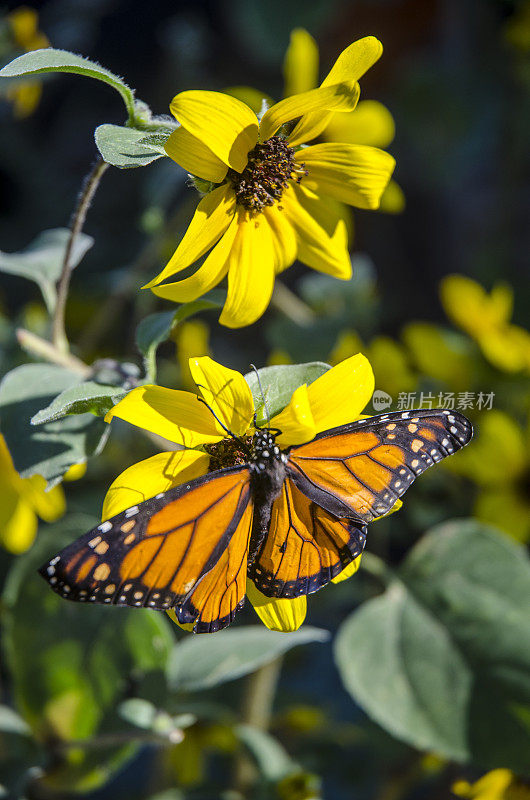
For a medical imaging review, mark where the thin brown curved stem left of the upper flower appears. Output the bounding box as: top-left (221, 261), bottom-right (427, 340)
top-left (52, 157), bottom-right (109, 353)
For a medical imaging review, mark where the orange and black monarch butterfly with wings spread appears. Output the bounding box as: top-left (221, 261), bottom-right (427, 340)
top-left (40, 410), bottom-right (472, 633)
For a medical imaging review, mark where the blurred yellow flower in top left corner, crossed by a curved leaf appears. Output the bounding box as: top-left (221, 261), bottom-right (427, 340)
top-left (6, 6), bottom-right (50, 118)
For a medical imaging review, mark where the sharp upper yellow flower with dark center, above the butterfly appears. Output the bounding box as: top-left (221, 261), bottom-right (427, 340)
top-left (144, 36), bottom-right (395, 328)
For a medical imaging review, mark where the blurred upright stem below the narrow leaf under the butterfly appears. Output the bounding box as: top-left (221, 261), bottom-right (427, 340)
top-left (233, 658), bottom-right (282, 797)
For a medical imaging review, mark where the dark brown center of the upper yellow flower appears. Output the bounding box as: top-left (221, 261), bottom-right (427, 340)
top-left (228, 136), bottom-right (307, 213)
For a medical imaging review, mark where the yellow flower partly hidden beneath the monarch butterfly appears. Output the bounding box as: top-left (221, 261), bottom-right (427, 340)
top-left (102, 354), bottom-right (374, 631)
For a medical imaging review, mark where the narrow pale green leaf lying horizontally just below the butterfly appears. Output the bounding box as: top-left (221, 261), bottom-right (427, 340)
top-left (167, 625), bottom-right (329, 691)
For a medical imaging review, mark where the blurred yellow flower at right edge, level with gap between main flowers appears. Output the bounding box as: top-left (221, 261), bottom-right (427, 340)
top-left (440, 275), bottom-right (530, 372)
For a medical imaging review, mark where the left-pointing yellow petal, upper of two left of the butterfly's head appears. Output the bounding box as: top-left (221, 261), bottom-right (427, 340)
top-left (105, 386), bottom-right (225, 447)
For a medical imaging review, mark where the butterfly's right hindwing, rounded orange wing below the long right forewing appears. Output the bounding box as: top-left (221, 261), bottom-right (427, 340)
top-left (250, 472), bottom-right (366, 597)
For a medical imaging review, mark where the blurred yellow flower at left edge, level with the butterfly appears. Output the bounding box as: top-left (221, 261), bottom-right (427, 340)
top-left (0, 435), bottom-right (66, 553)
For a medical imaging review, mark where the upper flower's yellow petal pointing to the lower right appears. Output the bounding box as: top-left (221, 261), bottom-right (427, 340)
top-left (282, 186), bottom-right (351, 280)
